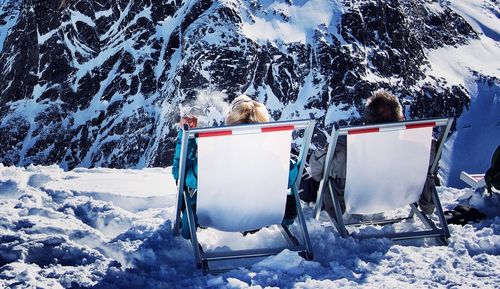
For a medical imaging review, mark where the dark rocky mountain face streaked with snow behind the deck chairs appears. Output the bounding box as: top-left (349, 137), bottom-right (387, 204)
top-left (0, 0), bottom-right (484, 169)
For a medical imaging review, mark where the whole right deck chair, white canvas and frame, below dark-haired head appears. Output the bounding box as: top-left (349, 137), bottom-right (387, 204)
top-left (314, 118), bottom-right (453, 244)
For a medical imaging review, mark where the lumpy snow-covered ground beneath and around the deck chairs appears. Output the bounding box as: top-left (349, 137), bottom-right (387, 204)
top-left (0, 165), bottom-right (500, 288)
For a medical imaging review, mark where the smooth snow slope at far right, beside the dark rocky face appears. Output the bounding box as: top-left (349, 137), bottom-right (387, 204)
top-left (429, 0), bottom-right (500, 188)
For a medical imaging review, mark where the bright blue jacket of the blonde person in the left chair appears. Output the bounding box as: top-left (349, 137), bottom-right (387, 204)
top-left (172, 130), bottom-right (299, 189)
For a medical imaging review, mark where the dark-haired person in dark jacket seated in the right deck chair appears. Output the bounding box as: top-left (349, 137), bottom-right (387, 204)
top-left (301, 90), bottom-right (435, 217)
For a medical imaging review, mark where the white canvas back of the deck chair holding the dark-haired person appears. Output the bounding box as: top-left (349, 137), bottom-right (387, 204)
top-left (344, 124), bottom-right (433, 214)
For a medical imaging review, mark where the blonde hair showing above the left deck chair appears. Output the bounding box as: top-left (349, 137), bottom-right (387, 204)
top-left (226, 95), bottom-right (269, 125)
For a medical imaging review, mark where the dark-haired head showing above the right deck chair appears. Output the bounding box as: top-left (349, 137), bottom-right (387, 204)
top-left (363, 90), bottom-right (404, 124)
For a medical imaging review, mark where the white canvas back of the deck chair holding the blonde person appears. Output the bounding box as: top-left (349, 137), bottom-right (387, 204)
top-left (196, 126), bottom-right (293, 232)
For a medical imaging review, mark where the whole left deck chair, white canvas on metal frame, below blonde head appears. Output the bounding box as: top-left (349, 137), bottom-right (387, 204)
top-left (173, 120), bottom-right (314, 273)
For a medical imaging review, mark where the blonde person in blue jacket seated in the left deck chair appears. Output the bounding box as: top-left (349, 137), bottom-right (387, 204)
top-left (172, 95), bottom-right (298, 239)
